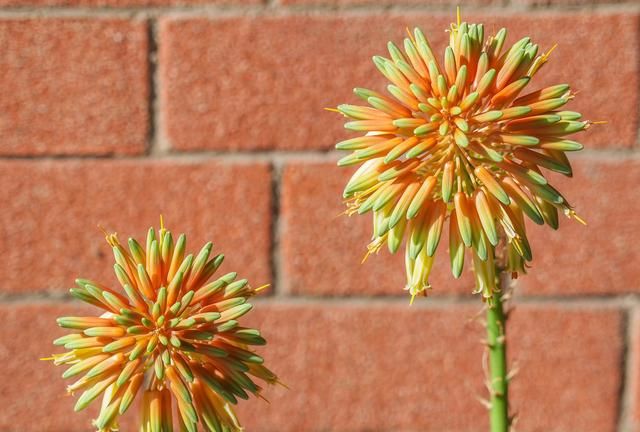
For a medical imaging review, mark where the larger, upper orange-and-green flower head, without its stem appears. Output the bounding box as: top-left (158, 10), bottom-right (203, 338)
top-left (336, 21), bottom-right (591, 301)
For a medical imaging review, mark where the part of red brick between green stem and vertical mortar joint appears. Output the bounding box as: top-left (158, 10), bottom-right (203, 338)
top-left (507, 303), bottom-right (623, 432)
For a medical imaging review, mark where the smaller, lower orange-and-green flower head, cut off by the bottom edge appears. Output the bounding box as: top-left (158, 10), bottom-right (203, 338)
top-left (47, 224), bottom-right (277, 432)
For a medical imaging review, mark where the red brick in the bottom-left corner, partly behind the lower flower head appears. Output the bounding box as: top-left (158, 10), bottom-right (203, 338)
top-left (0, 303), bottom-right (99, 432)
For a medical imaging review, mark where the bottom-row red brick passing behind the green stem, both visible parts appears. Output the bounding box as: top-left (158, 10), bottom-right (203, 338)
top-left (240, 301), bottom-right (622, 432)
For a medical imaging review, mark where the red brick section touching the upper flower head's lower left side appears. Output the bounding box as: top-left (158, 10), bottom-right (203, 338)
top-left (281, 162), bottom-right (473, 295)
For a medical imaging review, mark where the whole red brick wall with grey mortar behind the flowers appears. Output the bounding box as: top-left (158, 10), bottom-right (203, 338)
top-left (0, 0), bottom-right (640, 432)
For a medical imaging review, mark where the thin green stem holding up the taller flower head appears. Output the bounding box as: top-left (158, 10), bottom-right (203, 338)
top-left (487, 269), bottom-right (509, 432)
